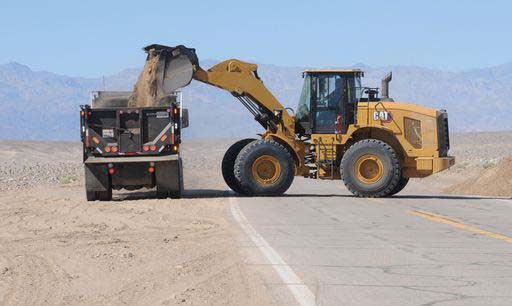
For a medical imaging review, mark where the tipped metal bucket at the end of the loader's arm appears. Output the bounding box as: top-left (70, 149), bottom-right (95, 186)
top-left (144, 44), bottom-right (199, 95)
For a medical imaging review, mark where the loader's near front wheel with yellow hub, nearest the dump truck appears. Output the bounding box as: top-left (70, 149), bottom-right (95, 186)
top-left (235, 140), bottom-right (295, 196)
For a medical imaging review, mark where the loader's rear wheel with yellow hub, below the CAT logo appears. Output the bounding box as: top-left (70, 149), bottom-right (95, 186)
top-left (340, 139), bottom-right (405, 198)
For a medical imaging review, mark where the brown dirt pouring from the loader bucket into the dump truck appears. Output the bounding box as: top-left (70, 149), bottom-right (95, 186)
top-left (128, 51), bottom-right (165, 107)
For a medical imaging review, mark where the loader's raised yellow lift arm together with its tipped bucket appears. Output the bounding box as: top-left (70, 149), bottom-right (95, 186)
top-left (140, 45), bottom-right (295, 139)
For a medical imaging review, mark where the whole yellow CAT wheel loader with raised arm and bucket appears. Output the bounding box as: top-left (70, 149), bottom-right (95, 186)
top-left (145, 45), bottom-right (455, 197)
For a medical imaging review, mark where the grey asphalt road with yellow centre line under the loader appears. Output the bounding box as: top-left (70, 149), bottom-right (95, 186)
top-left (231, 178), bottom-right (512, 306)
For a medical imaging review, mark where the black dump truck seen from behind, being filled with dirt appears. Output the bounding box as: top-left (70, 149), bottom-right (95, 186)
top-left (80, 91), bottom-right (188, 201)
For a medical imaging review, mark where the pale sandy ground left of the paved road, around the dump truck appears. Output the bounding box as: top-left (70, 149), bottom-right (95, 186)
top-left (0, 141), bottom-right (273, 305)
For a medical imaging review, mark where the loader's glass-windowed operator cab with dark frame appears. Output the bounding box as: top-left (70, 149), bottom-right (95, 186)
top-left (295, 69), bottom-right (363, 136)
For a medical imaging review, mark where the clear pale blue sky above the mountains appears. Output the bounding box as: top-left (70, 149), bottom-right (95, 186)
top-left (0, 0), bottom-right (512, 76)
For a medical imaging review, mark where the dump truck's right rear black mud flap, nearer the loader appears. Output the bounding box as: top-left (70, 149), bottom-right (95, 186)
top-left (155, 158), bottom-right (183, 198)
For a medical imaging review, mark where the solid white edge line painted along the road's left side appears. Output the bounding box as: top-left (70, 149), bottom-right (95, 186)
top-left (229, 198), bottom-right (317, 306)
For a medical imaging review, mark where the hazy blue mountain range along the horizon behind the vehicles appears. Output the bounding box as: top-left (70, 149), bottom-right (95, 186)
top-left (0, 61), bottom-right (512, 139)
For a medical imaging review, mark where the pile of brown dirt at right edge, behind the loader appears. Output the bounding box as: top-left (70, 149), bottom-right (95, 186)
top-left (444, 156), bottom-right (512, 197)
